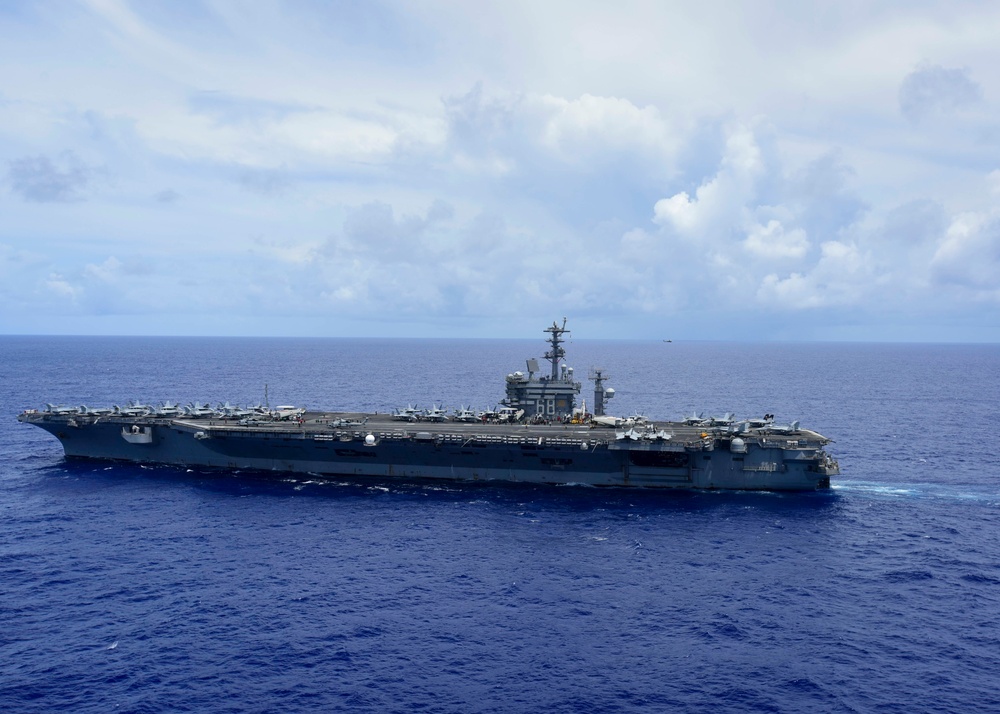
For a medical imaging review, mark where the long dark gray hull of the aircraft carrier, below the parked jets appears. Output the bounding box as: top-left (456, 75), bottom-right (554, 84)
top-left (18, 411), bottom-right (838, 490)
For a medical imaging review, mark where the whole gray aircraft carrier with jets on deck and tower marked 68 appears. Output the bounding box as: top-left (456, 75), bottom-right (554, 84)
top-left (17, 319), bottom-right (840, 491)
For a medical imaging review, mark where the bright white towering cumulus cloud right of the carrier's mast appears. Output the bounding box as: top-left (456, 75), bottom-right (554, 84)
top-left (636, 125), bottom-right (879, 310)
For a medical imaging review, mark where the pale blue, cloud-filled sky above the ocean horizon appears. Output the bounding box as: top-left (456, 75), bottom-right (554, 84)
top-left (0, 0), bottom-right (1000, 342)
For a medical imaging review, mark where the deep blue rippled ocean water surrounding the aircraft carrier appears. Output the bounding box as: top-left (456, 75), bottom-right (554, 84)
top-left (0, 337), bottom-right (1000, 712)
